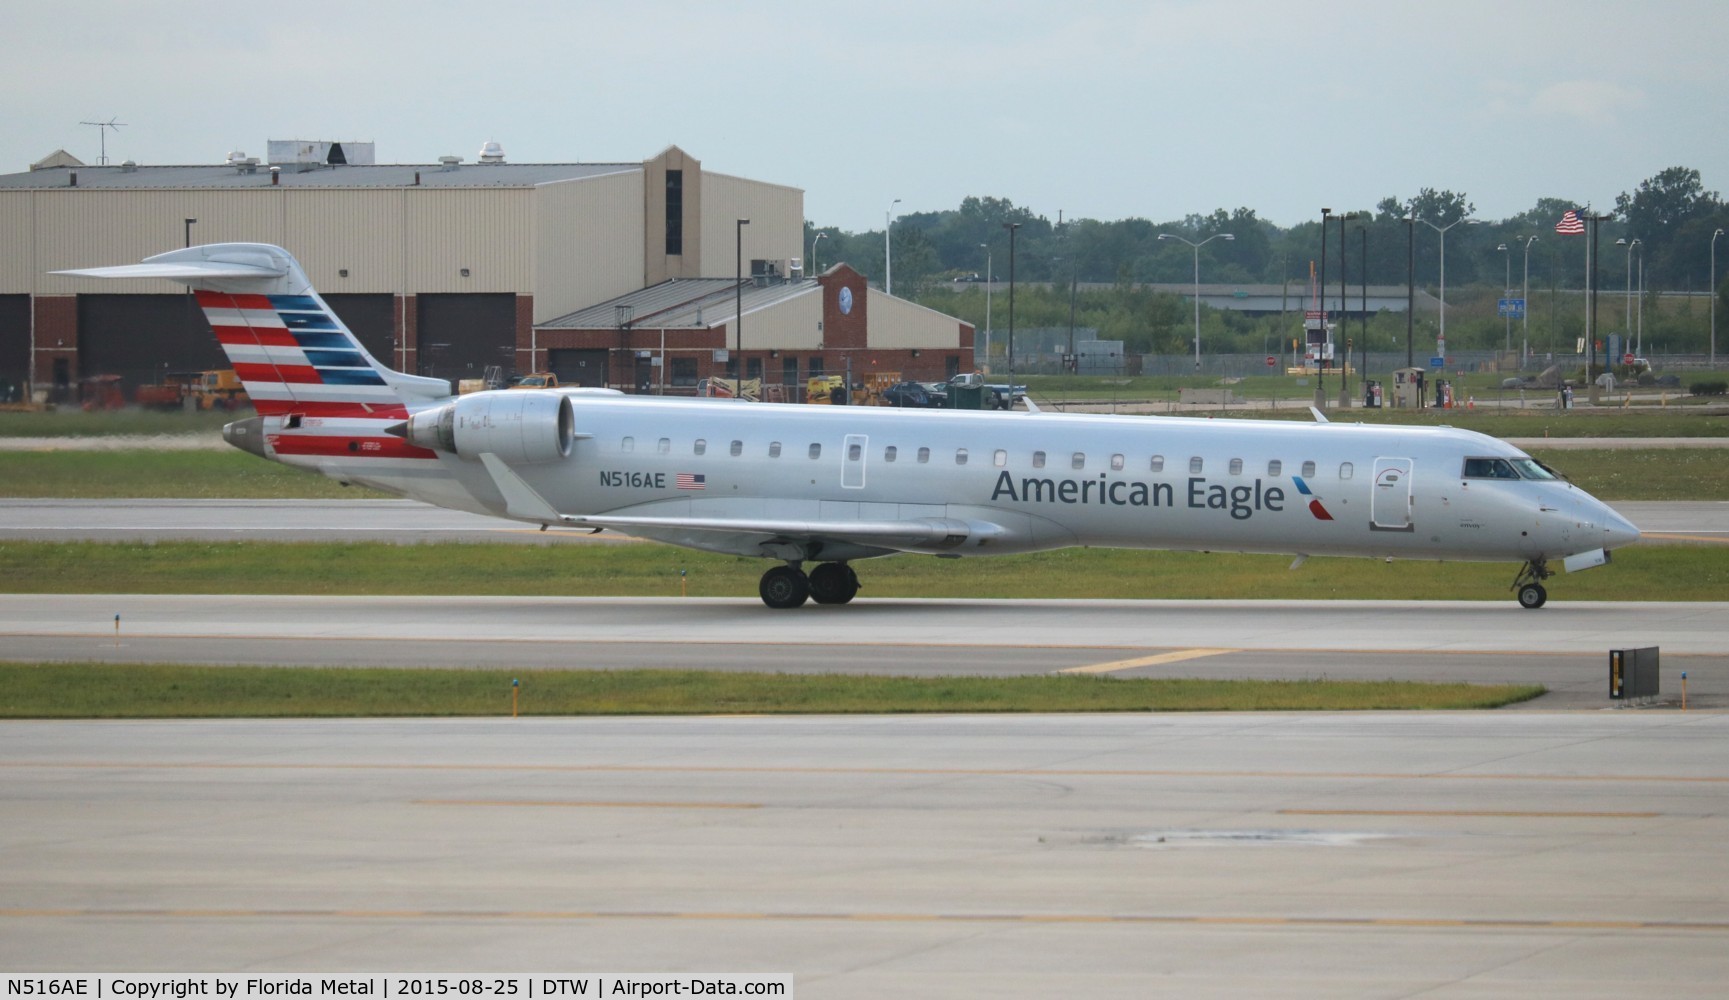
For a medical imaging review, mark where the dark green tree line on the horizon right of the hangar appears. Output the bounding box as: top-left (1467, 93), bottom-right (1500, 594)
top-left (804, 166), bottom-right (1729, 351)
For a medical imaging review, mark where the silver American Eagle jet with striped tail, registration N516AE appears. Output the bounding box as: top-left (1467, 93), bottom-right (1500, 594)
top-left (55, 244), bottom-right (1639, 609)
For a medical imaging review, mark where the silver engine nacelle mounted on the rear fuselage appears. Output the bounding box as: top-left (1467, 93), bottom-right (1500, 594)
top-left (406, 389), bottom-right (576, 464)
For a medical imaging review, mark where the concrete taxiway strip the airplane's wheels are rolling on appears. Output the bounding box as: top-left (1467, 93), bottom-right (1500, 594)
top-left (0, 593), bottom-right (1729, 709)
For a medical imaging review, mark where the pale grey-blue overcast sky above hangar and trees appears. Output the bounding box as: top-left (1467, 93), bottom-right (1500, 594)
top-left (0, 0), bottom-right (1729, 230)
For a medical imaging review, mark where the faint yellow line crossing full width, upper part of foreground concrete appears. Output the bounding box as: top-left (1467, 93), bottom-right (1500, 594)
top-left (0, 760), bottom-right (1729, 784)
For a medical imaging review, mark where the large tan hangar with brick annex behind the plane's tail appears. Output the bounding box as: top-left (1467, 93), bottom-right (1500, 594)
top-left (0, 140), bottom-right (973, 401)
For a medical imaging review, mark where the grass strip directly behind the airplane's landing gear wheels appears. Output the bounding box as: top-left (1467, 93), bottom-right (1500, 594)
top-left (0, 542), bottom-right (1729, 600)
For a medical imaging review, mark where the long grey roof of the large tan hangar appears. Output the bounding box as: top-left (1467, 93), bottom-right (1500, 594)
top-left (0, 163), bottom-right (643, 190)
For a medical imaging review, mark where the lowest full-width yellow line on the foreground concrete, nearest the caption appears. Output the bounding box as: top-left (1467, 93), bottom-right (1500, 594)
top-left (0, 907), bottom-right (1729, 934)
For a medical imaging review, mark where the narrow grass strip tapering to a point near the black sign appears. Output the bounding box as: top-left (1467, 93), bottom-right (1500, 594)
top-left (0, 663), bottom-right (1544, 718)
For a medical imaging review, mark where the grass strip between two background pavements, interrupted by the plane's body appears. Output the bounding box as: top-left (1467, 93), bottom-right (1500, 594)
top-left (0, 439), bottom-right (1729, 502)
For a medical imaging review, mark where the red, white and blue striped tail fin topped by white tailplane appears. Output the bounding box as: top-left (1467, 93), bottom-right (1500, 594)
top-left (55, 244), bottom-right (450, 420)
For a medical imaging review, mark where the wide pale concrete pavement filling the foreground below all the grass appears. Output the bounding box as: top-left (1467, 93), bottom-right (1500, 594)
top-left (0, 713), bottom-right (1729, 1000)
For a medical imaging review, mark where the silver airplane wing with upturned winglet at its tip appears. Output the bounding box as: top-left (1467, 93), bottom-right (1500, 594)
top-left (481, 453), bottom-right (1008, 552)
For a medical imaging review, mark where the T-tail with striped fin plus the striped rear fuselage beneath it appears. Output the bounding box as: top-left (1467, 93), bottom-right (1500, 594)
top-left (55, 244), bottom-right (450, 478)
